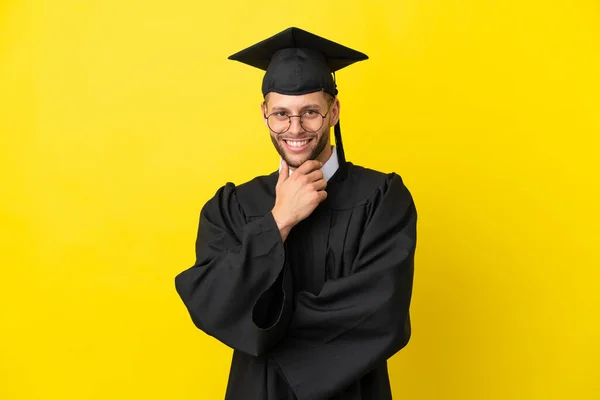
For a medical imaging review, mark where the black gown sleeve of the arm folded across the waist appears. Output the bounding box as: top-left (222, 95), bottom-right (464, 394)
top-left (269, 174), bottom-right (417, 400)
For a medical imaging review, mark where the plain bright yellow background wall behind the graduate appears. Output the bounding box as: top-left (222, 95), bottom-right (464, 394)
top-left (0, 0), bottom-right (600, 400)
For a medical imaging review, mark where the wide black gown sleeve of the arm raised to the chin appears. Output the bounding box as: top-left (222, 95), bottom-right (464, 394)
top-left (175, 183), bottom-right (291, 356)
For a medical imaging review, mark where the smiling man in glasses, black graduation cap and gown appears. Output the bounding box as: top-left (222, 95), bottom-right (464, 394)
top-left (175, 28), bottom-right (417, 400)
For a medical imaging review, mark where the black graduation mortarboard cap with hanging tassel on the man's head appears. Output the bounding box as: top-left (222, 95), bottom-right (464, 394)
top-left (229, 27), bottom-right (369, 166)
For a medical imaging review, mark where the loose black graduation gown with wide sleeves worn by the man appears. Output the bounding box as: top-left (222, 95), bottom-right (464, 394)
top-left (175, 162), bottom-right (417, 400)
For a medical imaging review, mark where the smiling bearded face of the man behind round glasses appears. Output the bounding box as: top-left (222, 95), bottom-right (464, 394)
top-left (261, 92), bottom-right (340, 168)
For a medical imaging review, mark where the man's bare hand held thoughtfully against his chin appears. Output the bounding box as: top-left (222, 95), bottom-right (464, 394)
top-left (272, 160), bottom-right (327, 241)
